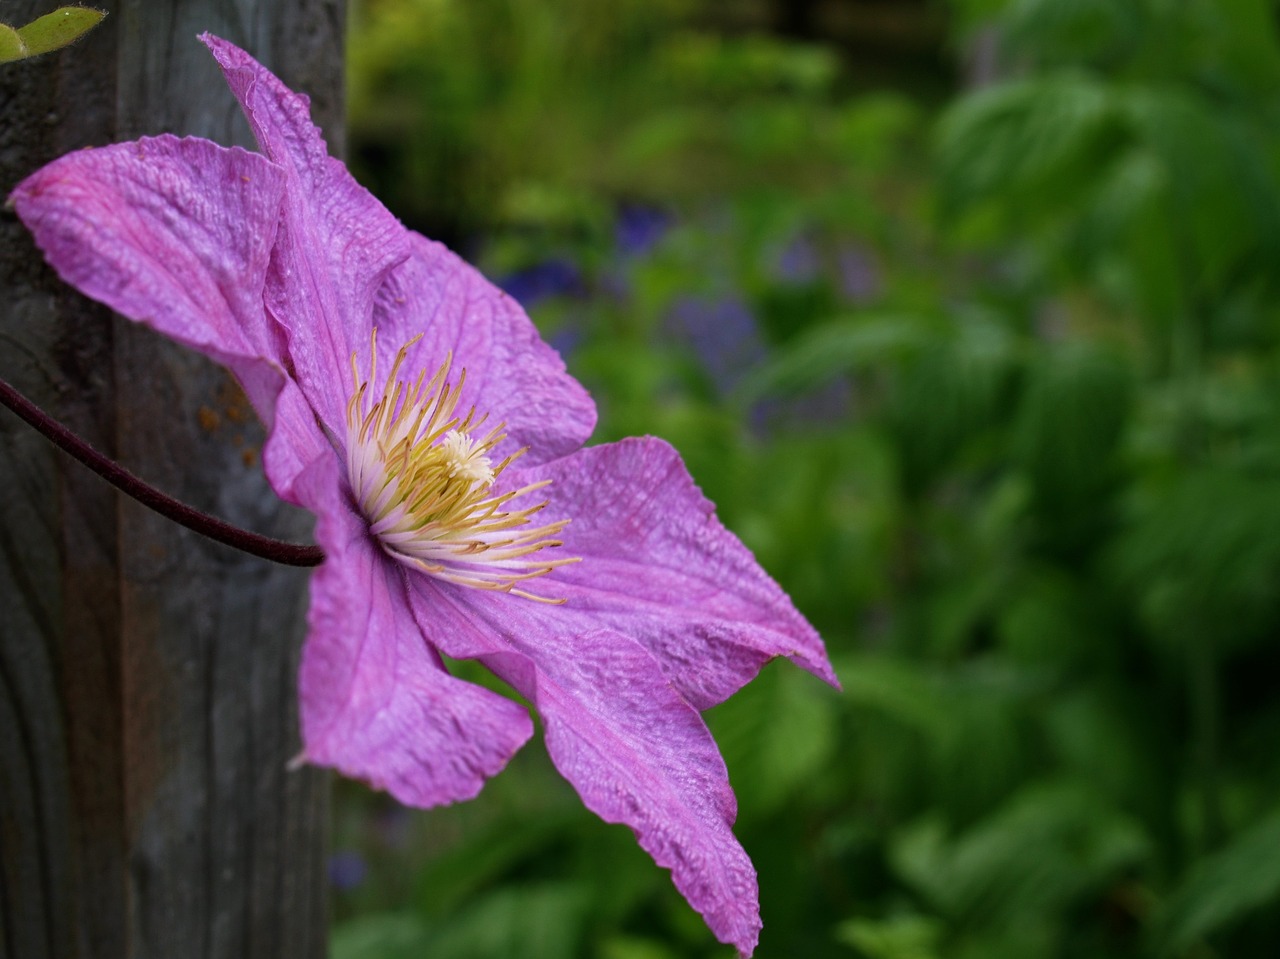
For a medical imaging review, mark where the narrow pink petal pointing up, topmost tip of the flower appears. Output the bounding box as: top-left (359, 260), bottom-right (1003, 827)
top-left (201, 33), bottom-right (407, 435)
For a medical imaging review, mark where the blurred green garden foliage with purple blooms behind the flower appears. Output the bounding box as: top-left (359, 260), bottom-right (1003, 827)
top-left (334, 0), bottom-right (1280, 959)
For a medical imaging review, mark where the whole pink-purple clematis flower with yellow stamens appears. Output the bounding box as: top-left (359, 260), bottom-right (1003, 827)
top-left (12, 35), bottom-right (836, 955)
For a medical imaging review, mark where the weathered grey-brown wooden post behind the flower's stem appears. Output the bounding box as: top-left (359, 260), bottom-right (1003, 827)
top-left (0, 0), bottom-right (344, 959)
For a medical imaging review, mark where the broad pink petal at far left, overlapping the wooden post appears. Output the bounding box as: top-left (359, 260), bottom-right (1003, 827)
top-left (12, 136), bottom-right (284, 424)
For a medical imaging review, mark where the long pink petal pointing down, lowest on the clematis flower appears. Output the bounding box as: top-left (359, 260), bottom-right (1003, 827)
top-left (410, 576), bottom-right (760, 956)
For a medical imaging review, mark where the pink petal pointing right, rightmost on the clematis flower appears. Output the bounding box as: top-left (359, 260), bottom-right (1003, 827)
top-left (503, 437), bottom-right (840, 709)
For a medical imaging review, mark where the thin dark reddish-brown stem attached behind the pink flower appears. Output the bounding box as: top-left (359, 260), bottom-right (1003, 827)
top-left (0, 379), bottom-right (324, 566)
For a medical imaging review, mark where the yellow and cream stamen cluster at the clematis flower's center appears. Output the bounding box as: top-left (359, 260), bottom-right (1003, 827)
top-left (347, 330), bottom-right (577, 603)
